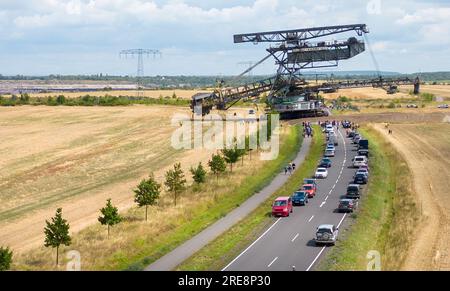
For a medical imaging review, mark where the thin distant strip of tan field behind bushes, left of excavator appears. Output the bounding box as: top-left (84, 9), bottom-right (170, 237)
top-left (26, 90), bottom-right (204, 99)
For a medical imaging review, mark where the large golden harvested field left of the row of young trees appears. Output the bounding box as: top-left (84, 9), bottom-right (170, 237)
top-left (0, 106), bottom-right (218, 252)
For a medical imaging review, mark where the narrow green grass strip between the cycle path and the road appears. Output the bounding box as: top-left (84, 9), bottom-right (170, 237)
top-left (177, 127), bottom-right (325, 271)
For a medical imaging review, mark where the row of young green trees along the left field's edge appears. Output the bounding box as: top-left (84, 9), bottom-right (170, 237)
top-left (0, 142), bottom-right (251, 271)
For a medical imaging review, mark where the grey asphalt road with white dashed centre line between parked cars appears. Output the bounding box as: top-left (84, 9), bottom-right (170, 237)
top-left (223, 130), bottom-right (356, 271)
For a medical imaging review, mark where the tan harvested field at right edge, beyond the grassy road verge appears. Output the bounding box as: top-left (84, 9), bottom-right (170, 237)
top-left (375, 123), bottom-right (450, 271)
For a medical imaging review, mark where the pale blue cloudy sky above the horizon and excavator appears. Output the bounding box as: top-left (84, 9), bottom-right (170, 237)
top-left (0, 0), bottom-right (450, 75)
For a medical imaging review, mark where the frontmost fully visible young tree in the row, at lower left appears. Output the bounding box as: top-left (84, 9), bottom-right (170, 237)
top-left (44, 208), bottom-right (72, 266)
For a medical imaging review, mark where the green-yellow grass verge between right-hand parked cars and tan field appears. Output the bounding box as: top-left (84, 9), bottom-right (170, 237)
top-left (319, 128), bottom-right (419, 271)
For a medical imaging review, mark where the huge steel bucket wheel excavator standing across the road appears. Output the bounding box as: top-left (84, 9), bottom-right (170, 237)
top-left (191, 24), bottom-right (420, 119)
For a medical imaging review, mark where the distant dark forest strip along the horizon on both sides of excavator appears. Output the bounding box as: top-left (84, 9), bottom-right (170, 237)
top-left (0, 71), bottom-right (450, 89)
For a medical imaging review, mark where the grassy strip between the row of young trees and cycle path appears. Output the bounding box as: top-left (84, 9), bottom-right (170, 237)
top-left (14, 127), bottom-right (302, 270)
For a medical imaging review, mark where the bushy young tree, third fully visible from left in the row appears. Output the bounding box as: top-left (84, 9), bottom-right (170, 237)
top-left (133, 174), bottom-right (161, 221)
